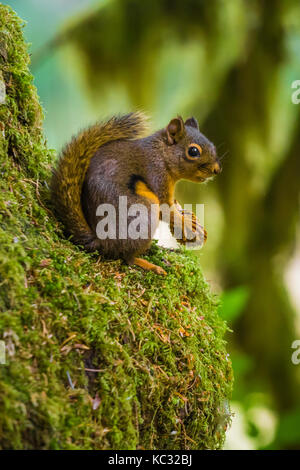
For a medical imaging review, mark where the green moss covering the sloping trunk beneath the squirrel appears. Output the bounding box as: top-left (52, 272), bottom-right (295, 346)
top-left (0, 5), bottom-right (232, 449)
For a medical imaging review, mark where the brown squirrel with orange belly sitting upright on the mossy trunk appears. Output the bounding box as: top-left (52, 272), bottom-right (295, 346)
top-left (51, 112), bottom-right (221, 274)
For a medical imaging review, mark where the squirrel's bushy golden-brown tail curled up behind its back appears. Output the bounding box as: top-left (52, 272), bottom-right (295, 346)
top-left (51, 112), bottom-right (147, 251)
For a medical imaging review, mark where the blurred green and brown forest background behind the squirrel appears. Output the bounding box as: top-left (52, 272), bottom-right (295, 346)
top-left (4, 0), bottom-right (300, 449)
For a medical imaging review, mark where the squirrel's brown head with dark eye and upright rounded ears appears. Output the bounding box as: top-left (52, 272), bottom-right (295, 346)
top-left (163, 116), bottom-right (222, 183)
